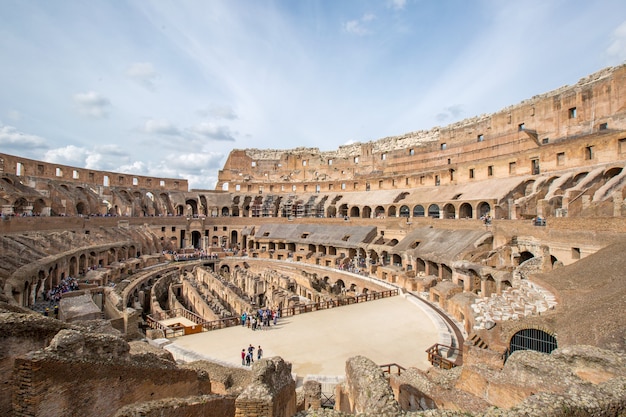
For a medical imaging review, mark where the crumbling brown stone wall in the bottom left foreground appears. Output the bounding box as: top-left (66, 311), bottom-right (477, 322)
top-left (13, 330), bottom-right (211, 417)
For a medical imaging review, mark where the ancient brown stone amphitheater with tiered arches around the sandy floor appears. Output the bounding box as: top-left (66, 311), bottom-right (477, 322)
top-left (0, 66), bottom-right (626, 417)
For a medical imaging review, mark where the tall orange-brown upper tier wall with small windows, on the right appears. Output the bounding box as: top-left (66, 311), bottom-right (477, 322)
top-left (217, 65), bottom-right (626, 191)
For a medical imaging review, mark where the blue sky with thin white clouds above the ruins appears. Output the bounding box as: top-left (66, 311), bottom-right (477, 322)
top-left (0, 0), bottom-right (626, 189)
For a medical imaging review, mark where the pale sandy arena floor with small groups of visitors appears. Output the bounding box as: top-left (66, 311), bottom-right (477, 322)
top-left (166, 296), bottom-right (439, 377)
